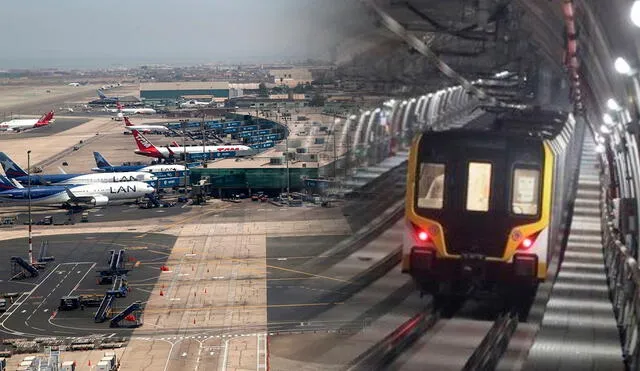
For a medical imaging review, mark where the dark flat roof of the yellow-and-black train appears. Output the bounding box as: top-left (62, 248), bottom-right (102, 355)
top-left (444, 107), bottom-right (568, 139)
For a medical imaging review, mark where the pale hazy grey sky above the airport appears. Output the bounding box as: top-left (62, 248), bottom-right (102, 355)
top-left (0, 0), bottom-right (364, 68)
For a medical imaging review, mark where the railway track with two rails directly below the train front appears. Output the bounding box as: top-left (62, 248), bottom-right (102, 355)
top-left (346, 308), bottom-right (518, 371)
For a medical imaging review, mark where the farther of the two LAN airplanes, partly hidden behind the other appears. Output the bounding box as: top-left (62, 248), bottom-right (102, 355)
top-left (0, 152), bottom-right (156, 185)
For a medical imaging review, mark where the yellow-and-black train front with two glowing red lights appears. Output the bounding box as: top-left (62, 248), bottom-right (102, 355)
top-left (402, 115), bottom-right (575, 304)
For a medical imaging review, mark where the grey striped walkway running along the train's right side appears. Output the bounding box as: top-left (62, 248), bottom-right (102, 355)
top-left (524, 136), bottom-right (624, 371)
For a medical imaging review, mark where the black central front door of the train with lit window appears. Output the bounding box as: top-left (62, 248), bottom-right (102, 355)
top-left (449, 147), bottom-right (509, 257)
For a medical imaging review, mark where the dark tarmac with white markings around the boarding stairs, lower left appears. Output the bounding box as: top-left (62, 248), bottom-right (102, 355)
top-left (0, 232), bottom-right (176, 338)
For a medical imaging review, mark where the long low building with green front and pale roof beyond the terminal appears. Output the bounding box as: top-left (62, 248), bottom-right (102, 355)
top-left (140, 81), bottom-right (229, 101)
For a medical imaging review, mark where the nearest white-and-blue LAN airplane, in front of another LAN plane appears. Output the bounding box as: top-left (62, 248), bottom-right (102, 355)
top-left (0, 175), bottom-right (154, 208)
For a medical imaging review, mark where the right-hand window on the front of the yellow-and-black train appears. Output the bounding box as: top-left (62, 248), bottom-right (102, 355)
top-left (511, 169), bottom-right (540, 215)
